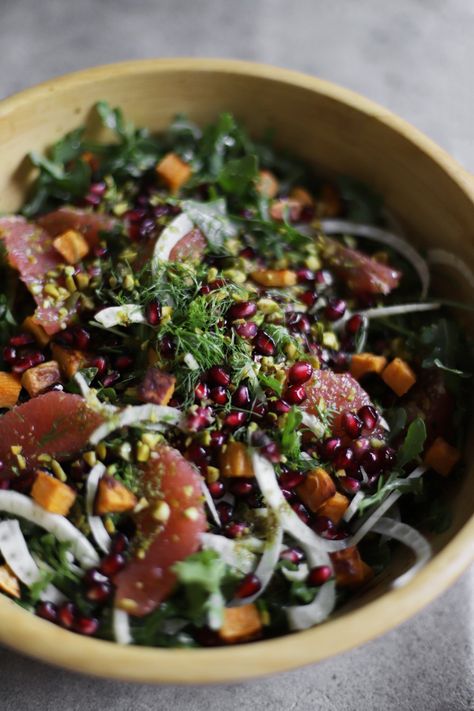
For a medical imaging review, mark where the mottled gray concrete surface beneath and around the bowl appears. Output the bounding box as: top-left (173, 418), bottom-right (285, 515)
top-left (0, 0), bottom-right (474, 711)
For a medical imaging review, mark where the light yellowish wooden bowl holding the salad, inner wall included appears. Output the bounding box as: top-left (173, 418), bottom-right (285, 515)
top-left (0, 59), bottom-right (474, 683)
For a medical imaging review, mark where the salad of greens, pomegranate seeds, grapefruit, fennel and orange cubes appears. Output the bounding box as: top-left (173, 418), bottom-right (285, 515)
top-left (0, 102), bottom-right (470, 647)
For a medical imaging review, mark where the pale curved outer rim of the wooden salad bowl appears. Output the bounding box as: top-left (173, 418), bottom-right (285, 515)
top-left (0, 58), bottom-right (474, 684)
